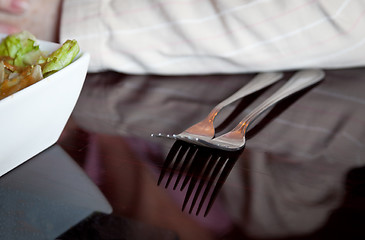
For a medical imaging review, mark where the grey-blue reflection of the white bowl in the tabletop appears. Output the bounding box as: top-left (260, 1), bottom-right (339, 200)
top-left (0, 145), bottom-right (112, 240)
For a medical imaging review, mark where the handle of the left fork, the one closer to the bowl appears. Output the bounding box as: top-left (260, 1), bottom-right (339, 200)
top-left (208, 72), bottom-right (283, 122)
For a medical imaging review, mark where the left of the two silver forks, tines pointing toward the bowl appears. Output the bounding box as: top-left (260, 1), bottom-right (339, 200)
top-left (151, 72), bottom-right (283, 140)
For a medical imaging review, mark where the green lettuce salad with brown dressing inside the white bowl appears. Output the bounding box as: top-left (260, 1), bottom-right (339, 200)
top-left (0, 31), bottom-right (80, 99)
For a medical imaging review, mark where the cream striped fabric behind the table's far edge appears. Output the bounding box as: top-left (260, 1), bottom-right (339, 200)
top-left (61, 0), bottom-right (365, 74)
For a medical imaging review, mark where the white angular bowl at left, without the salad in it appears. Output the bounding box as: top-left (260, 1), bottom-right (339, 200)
top-left (0, 35), bottom-right (90, 176)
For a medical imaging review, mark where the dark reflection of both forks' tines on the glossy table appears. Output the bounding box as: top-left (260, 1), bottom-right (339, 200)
top-left (157, 140), bottom-right (243, 216)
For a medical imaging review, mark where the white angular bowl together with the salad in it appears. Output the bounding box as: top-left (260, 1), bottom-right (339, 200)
top-left (0, 32), bottom-right (90, 176)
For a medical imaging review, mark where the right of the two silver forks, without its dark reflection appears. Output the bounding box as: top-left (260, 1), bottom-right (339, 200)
top-left (194, 69), bottom-right (325, 151)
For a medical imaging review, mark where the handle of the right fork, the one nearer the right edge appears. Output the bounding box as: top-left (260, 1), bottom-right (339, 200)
top-left (232, 69), bottom-right (325, 133)
